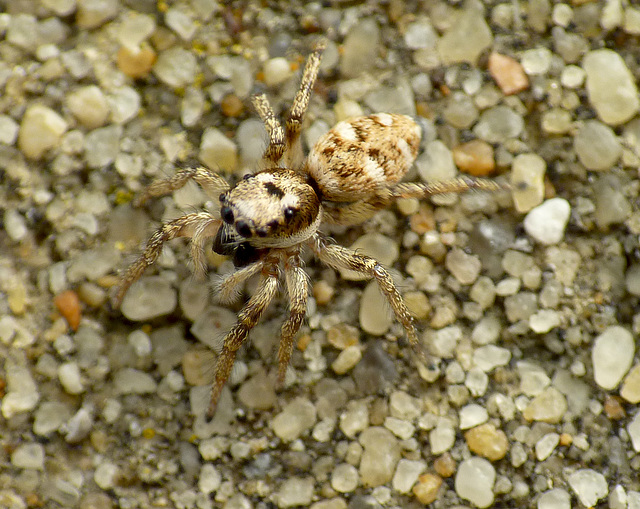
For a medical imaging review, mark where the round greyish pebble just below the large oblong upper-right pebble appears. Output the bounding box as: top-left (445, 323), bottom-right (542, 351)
top-left (573, 120), bottom-right (622, 171)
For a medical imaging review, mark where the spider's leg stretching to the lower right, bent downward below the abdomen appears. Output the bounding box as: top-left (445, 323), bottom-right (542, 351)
top-left (312, 235), bottom-right (427, 360)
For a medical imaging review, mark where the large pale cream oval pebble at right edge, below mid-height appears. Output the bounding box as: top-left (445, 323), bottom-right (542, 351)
top-left (591, 325), bottom-right (635, 390)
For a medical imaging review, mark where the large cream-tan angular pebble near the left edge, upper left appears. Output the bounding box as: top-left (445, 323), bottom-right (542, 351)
top-left (18, 104), bottom-right (68, 159)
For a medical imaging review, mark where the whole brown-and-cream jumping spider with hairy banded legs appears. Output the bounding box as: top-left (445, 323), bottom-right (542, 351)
top-left (114, 44), bottom-right (501, 417)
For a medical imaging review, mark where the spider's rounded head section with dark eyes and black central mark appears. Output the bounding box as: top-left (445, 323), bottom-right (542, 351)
top-left (220, 168), bottom-right (320, 247)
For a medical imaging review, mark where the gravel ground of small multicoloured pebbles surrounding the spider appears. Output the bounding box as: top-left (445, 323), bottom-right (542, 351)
top-left (0, 0), bottom-right (640, 509)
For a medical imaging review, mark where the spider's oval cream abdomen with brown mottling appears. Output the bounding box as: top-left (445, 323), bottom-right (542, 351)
top-left (306, 113), bottom-right (421, 202)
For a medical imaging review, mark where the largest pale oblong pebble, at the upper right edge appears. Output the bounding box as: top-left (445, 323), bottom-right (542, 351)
top-left (582, 49), bottom-right (640, 125)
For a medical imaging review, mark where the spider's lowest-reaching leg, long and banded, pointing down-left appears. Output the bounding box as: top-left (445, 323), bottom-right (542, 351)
top-left (207, 257), bottom-right (279, 419)
